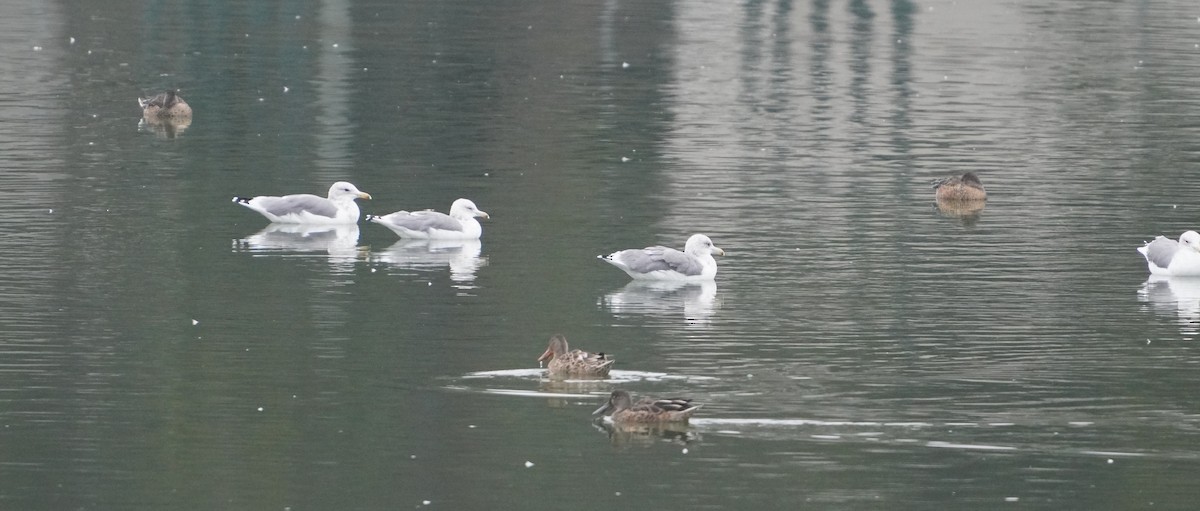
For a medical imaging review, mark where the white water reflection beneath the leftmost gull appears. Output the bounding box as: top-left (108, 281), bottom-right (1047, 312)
top-left (234, 223), bottom-right (359, 265)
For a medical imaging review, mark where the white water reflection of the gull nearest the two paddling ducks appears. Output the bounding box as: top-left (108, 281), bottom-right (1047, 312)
top-left (601, 281), bottom-right (720, 325)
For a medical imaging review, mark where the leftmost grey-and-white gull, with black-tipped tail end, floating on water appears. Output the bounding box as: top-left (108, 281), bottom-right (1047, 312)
top-left (233, 181), bottom-right (371, 224)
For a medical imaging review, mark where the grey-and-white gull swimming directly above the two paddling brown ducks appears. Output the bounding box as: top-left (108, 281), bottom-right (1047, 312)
top-left (599, 234), bottom-right (725, 281)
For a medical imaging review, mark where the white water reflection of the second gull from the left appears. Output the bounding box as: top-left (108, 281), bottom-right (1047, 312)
top-left (371, 240), bottom-right (487, 284)
